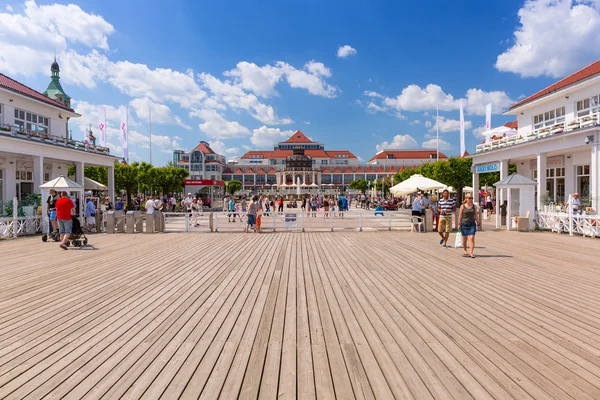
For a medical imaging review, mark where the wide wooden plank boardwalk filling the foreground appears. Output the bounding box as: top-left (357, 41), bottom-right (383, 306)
top-left (0, 230), bottom-right (600, 400)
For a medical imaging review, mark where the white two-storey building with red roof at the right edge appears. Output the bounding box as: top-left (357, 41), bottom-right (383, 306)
top-left (471, 60), bottom-right (600, 222)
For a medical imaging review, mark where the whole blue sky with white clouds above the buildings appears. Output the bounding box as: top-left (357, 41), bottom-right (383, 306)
top-left (0, 0), bottom-right (600, 164)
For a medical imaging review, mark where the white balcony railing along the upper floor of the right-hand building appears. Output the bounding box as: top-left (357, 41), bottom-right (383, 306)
top-left (475, 113), bottom-right (600, 153)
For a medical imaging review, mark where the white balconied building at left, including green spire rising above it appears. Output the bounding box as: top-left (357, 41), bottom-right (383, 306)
top-left (0, 60), bottom-right (115, 215)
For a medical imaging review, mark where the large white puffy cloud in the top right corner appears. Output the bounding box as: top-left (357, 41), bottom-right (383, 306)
top-left (495, 0), bottom-right (600, 78)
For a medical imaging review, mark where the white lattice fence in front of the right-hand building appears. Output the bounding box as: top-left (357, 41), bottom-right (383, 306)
top-left (535, 212), bottom-right (600, 238)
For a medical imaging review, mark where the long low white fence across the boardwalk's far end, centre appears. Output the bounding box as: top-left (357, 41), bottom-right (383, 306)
top-left (165, 209), bottom-right (412, 232)
